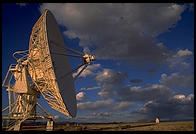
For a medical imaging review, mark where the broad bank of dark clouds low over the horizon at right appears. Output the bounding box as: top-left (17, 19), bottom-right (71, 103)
top-left (78, 81), bottom-right (194, 122)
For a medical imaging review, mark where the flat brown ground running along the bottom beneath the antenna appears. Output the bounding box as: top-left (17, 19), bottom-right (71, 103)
top-left (2, 121), bottom-right (194, 131)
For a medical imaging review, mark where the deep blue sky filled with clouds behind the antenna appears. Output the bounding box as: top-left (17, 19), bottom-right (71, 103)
top-left (2, 3), bottom-right (194, 122)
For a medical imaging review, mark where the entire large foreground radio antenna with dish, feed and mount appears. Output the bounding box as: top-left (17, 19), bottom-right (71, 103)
top-left (2, 10), bottom-right (94, 130)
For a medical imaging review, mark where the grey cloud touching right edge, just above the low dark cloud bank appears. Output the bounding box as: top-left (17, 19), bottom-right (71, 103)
top-left (160, 73), bottom-right (194, 89)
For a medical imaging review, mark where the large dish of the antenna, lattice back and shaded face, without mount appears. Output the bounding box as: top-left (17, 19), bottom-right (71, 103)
top-left (28, 10), bottom-right (77, 117)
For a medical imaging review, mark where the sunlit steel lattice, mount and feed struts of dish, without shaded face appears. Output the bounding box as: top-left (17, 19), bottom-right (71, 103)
top-left (2, 10), bottom-right (94, 130)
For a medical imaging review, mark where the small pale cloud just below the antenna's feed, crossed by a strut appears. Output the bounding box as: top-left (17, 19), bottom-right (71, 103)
top-left (73, 64), bottom-right (101, 77)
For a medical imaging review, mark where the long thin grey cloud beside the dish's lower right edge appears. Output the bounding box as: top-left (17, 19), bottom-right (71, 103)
top-left (77, 99), bottom-right (113, 110)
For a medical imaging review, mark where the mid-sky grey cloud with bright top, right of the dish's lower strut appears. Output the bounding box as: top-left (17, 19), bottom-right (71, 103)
top-left (95, 69), bottom-right (127, 98)
